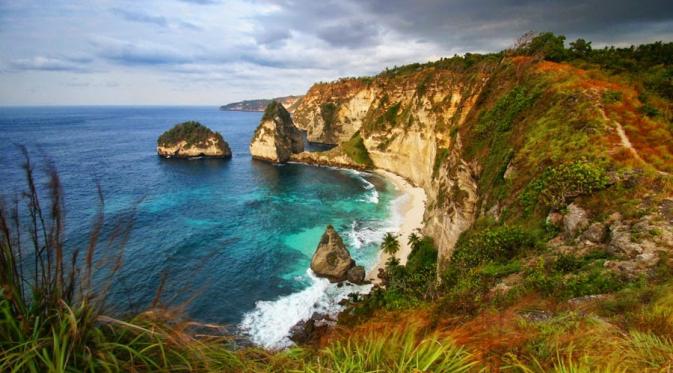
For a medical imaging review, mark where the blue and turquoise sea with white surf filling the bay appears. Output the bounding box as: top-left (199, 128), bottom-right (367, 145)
top-left (0, 107), bottom-right (397, 347)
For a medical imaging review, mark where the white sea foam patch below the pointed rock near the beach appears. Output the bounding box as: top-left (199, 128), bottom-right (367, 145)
top-left (239, 269), bottom-right (371, 349)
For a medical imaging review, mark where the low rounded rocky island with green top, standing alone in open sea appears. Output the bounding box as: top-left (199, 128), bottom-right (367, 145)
top-left (157, 121), bottom-right (231, 159)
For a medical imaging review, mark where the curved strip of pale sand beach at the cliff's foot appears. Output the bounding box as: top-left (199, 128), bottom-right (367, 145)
top-left (367, 169), bottom-right (426, 283)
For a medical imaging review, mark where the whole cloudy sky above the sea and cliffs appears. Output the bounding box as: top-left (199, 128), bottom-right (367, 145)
top-left (0, 0), bottom-right (673, 105)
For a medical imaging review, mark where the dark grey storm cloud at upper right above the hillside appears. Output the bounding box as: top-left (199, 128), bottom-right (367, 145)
top-left (363, 0), bottom-right (673, 49)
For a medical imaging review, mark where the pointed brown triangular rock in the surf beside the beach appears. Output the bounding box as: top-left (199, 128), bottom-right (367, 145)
top-left (311, 225), bottom-right (355, 282)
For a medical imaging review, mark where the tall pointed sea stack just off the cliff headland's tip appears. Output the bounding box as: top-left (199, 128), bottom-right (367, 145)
top-left (250, 101), bottom-right (304, 163)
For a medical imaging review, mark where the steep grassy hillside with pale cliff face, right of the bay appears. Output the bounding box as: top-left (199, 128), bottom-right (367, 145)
top-left (286, 34), bottom-right (673, 371)
